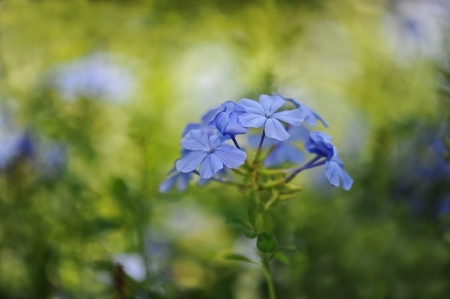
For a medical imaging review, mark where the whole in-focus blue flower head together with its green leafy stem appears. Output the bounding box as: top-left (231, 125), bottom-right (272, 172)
top-left (160, 94), bottom-right (353, 299)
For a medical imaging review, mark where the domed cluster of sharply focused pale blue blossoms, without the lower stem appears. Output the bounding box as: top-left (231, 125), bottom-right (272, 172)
top-left (160, 94), bottom-right (353, 192)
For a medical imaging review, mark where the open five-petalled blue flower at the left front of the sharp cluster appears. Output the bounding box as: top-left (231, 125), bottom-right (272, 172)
top-left (175, 130), bottom-right (246, 179)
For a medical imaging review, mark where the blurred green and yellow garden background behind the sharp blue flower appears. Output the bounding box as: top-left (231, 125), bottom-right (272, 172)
top-left (0, 0), bottom-right (450, 299)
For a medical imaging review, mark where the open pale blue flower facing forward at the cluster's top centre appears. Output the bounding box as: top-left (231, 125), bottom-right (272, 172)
top-left (239, 95), bottom-right (303, 140)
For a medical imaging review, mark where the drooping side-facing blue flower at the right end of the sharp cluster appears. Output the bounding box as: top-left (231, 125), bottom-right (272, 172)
top-left (305, 131), bottom-right (353, 190)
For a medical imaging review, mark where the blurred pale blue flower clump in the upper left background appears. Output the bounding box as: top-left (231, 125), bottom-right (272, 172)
top-left (49, 53), bottom-right (135, 103)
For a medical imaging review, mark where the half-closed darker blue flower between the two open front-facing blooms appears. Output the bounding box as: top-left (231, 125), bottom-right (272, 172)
top-left (210, 101), bottom-right (248, 136)
